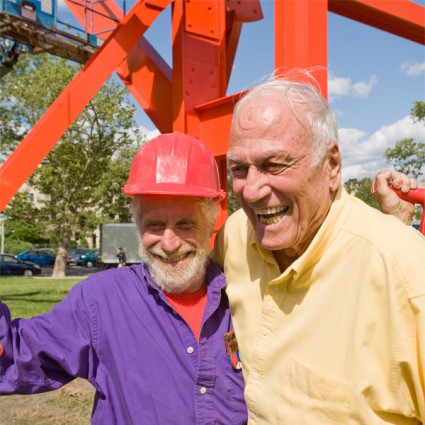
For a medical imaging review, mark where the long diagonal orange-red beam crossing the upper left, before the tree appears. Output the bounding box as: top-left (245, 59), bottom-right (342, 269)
top-left (0, 0), bottom-right (171, 211)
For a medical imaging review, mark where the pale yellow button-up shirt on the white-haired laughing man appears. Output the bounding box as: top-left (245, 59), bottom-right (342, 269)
top-left (214, 188), bottom-right (425, 425)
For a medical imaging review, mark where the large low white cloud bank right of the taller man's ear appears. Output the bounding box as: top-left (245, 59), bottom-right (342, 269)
top-left (339, 116), bottom-right (425, 181)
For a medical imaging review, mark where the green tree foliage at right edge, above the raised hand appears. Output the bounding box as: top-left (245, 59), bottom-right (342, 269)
top-left (384, 101), bottom-right (425, 178)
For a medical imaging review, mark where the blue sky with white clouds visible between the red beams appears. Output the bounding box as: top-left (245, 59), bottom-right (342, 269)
top-left (58, 0), bottom-right (425, 181)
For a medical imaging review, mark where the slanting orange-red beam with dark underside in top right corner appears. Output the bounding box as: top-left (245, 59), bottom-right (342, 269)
top-left (328, 0), bottom-right (425, 44)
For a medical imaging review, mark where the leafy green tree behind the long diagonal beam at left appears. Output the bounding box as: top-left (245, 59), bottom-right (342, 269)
top-left (0, 54), bottom-right (144, 277)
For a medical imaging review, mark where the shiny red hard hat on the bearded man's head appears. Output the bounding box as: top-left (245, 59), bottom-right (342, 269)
top-left (122, 133), bottom-right (226, 200)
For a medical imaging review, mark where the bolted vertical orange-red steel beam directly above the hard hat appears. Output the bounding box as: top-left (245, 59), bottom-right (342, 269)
top-left (172, 0), bottom-right (227, 136)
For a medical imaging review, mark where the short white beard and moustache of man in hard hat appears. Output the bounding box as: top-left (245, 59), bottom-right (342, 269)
top-left (139, 241), bottom-right (208, 294)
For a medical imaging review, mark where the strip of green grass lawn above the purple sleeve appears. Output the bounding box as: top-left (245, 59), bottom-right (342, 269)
top-left (0, 277), bottom-right (81, 318)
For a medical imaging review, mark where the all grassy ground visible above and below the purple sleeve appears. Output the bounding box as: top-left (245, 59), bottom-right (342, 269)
top-left (0, 277), bottom-right (94, 425)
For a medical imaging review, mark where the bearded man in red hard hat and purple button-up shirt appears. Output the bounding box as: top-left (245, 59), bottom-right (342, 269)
top-left (0, 133), bottom-right (247, 425)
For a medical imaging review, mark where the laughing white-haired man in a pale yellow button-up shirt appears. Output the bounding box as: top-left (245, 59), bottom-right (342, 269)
top-left (214, 74), bottom-right (425, 425)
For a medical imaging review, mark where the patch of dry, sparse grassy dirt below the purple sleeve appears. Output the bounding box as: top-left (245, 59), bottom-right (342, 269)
top-left (0, 379), bottom-right (94, 425)
